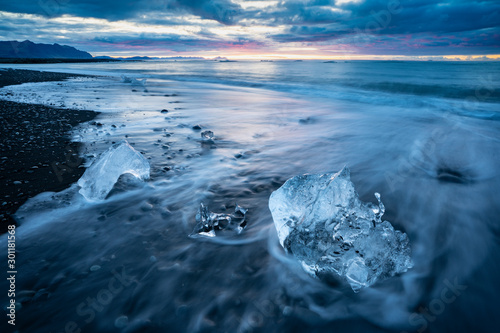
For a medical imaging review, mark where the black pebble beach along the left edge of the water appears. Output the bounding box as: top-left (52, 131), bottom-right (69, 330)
top-left (0, 69), bottom-right (99, 228)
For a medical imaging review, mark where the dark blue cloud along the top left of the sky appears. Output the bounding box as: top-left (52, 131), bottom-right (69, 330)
top-left (0, 0), bottom-right (241, 24)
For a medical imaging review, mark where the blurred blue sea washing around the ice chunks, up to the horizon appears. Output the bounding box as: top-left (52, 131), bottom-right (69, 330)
top-left (0, 60), bottom-right (500, 333)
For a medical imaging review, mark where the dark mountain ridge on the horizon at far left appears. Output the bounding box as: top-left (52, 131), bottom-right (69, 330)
top-left (0, 40), bottom-right (92, 59)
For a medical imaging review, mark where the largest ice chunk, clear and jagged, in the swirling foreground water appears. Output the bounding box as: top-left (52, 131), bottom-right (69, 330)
top-left (269, 167), bottom-right (413, 292)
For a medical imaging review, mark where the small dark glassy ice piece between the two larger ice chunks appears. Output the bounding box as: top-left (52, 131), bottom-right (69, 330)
top-left (193, 203), bottom-right (247, 237)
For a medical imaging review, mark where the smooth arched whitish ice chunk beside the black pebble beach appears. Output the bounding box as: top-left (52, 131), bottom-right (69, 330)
top-left (78, 140), bottom-right (150, 200)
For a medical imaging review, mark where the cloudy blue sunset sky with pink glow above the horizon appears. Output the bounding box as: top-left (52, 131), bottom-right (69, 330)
top-left (0, 0), bottom-right (500, 60)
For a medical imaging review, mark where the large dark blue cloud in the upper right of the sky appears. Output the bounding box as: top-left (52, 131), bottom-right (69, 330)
top-left (260, 0), bottom-right (500, 42)
